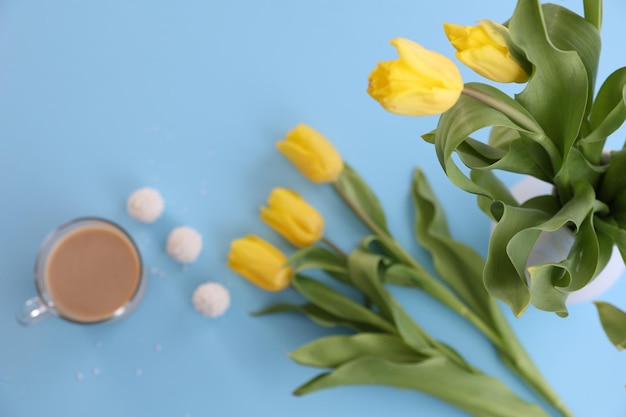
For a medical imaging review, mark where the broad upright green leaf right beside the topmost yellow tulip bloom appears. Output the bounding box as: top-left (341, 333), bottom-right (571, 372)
top-left (509, 1), bottom-right (590, 162)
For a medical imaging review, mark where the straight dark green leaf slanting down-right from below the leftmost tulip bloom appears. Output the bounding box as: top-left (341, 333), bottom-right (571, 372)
top-left (291, 274), bottom-right (396, 334)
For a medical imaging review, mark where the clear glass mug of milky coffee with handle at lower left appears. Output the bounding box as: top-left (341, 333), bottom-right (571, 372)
top-left (18, 217), bottom-right (147, 325)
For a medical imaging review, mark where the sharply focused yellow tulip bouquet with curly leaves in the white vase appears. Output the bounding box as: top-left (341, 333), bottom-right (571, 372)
top-left (368, 0), bottom-right (626, 348)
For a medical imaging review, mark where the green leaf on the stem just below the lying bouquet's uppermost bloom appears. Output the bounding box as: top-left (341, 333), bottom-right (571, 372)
top-left (334, 163), bottom-right (389, 234)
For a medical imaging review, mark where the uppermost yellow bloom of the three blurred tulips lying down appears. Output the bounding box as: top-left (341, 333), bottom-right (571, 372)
top-left (276, 124), bottom-right (343, 183)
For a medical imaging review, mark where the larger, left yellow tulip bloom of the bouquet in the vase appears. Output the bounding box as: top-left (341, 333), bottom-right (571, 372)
top-left (367, 38), bottom-right (463, 116)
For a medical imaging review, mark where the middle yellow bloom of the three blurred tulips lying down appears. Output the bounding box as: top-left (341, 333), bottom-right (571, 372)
top-left (261, 188), bottom-right (324, 247)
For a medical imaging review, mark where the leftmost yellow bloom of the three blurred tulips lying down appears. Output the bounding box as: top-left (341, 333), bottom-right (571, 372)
top-left (228, 235), bottom-right (292, 291)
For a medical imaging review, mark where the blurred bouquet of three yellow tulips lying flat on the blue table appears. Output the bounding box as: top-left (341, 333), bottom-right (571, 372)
top-left (228, 125), bottom-right (573, 417)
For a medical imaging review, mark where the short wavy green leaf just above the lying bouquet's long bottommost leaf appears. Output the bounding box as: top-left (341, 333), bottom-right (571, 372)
top-left (289, 333), bottom-right (424, 368)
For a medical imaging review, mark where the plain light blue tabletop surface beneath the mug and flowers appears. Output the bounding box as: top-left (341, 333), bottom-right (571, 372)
top-left (0, 0), bottom-right (626, 417)
